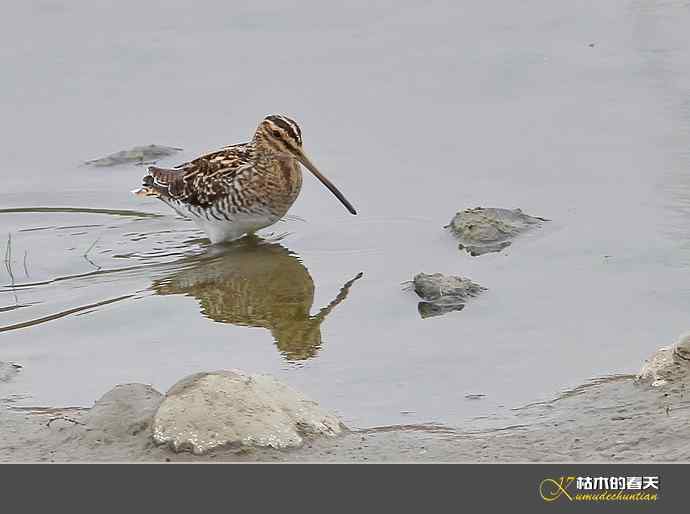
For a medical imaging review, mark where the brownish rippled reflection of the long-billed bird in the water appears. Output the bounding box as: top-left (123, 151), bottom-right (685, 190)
top-left (153, 237), bottom-right (362, 361)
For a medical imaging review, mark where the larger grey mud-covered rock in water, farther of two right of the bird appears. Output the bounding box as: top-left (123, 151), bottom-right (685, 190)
top-left (446, 207), bottom-right (548, 256)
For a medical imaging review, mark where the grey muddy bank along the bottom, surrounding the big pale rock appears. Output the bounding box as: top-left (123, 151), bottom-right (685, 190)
top-left (0, 362), bottom-right (690, 462)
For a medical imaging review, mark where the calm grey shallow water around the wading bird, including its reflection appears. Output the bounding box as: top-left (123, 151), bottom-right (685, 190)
top-left (0, 0), bottom-right (690, 427)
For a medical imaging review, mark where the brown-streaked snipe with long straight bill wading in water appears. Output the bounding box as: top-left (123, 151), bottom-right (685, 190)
top-left (132, 115), bottom-right (357, 243)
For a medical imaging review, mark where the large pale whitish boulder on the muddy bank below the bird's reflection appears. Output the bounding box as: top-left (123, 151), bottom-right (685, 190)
top-left (153, 370), bottom-right (346, 454)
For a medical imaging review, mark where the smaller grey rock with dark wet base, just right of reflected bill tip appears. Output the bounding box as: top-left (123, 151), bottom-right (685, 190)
top-left (412, 273), bottom-right (486, 318)
